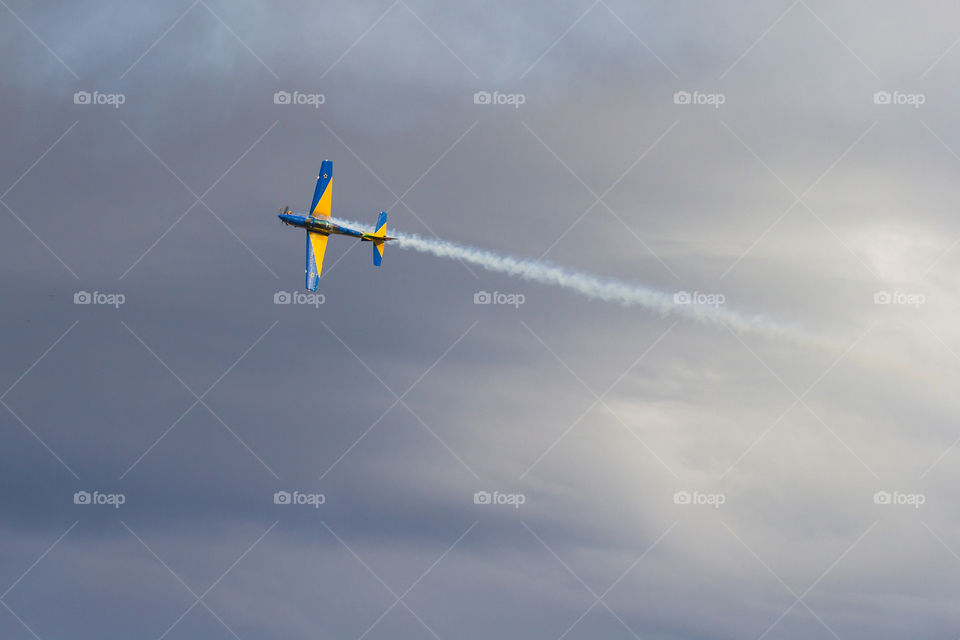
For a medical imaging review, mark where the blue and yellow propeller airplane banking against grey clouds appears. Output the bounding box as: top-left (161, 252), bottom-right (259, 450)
top-left (277, 160), bottom-right (396, 291)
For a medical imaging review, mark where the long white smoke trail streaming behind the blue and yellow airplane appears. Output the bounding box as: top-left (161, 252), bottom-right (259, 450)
top-left (334, 220), bottom-right (809, 341)
